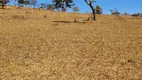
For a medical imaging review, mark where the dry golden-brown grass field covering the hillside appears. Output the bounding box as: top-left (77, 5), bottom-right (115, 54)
top-left (0, 8), bottom-right (142, 80)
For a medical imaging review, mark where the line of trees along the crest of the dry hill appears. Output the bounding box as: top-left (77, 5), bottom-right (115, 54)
top-left (0, 0), bottom-right (142, 21)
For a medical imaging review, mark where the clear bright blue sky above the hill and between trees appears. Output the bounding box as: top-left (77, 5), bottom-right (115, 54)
top-left (10, 0), bottom-right (142, 14)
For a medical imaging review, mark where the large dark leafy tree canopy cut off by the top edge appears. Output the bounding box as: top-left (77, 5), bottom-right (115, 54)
top-left (52, 0), bottom-right (74, 11)
